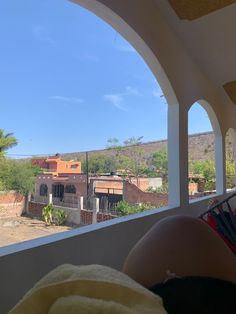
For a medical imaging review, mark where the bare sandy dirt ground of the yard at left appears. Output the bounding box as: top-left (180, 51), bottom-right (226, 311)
top-left (0, 217), bottom-right (72, 247)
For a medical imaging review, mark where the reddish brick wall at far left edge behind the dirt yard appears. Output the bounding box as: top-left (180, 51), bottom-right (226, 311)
top-left (0, 191), bottom-right (25, 218)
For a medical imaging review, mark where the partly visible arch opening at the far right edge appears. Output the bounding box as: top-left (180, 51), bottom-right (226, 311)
top-left (225, 129), bottom-right (236, 191)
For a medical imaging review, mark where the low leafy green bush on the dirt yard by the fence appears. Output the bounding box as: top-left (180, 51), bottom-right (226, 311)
top-left (42, 204), bottom-right (67, 226)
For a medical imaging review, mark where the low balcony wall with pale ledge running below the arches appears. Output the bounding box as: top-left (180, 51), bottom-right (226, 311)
top-left (0, 196), bottom-right (234, 313)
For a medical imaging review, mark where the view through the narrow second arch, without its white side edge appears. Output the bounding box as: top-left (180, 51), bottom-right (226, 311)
top-left (188, 103), bottom-right (216, 199)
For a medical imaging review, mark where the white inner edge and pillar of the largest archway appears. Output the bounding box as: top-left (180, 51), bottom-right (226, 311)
top-left (70, 0), bottom-right (182, 206)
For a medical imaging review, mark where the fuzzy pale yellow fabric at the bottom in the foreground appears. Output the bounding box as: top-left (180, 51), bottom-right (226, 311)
top-left (9, 265), bottom-right (166, 314)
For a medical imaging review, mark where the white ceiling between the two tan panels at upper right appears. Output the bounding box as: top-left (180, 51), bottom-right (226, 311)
top-left (156, 0), bottom-right (236, 86)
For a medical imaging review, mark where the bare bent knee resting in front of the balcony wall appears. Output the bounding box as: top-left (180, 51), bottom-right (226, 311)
top-left (123, 216), bottom-right (236, 287)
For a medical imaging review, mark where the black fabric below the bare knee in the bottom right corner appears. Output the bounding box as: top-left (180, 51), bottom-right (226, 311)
top-left (150, 277), bottom-right (236, 314)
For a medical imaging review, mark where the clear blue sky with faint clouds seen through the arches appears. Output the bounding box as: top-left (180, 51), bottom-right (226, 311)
top-left (0, 0), bottom-right (212, 156)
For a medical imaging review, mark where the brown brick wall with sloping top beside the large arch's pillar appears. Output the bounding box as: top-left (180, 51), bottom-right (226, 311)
top-left (124, 182), bottom-right (168, 206)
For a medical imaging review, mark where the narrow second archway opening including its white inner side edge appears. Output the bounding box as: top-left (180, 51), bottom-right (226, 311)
top-left (188, 100), bottom-right (223, 200)
